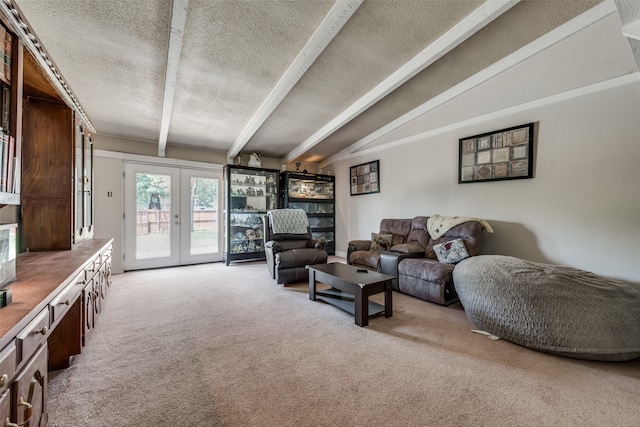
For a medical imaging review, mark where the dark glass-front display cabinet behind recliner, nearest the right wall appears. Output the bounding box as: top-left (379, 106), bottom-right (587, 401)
top-left (280, 172), bottom-right (336, 255)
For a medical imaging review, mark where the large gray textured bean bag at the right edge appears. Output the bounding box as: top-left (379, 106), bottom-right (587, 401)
top-left (453, 255), bottom-right (640, 361)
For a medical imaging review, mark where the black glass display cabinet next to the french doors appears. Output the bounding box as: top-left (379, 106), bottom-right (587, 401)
top-left (222, 165), bottom-right (280, 265)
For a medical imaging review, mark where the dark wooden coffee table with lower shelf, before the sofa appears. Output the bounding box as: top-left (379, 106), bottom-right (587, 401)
top-left (308, 262), bottom-right (394, 326)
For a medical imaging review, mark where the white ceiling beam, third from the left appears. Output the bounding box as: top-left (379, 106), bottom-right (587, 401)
top-left (283, 0), bottom-right (520, 163)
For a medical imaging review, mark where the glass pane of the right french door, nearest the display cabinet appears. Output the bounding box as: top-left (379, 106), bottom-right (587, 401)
top-left (190, 177), bottom-right (218, 255)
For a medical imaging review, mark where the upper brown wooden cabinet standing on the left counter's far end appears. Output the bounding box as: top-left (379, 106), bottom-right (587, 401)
top-left (21, 97), bottom-right (93, 251)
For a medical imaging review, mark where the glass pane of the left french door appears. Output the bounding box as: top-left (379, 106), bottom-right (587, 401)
top-left (135, 173), bottom-right (171, 259)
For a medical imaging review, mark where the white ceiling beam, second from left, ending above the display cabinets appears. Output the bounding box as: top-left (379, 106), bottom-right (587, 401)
top-left (227, 0), bottom-right (363, 163)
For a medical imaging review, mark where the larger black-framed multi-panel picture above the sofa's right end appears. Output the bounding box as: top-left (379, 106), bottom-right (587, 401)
top-left (458, 123), bottom-right (534, 184)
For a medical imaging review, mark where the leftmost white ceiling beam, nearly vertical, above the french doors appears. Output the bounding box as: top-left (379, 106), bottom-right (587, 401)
top-left (158, 0), bottom-right (189, 157)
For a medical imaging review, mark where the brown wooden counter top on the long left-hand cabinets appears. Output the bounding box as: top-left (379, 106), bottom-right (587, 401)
top-left (0, 239), bottom-right (113, 350)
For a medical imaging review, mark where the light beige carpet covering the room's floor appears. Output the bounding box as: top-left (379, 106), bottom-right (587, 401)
top-left (49, 262), bottom-right (640, 427)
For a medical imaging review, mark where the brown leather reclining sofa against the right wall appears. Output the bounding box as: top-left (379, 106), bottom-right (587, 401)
top-left (347, 216), bottom-right (483, 305)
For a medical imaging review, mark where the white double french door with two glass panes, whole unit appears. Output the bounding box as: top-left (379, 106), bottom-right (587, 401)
top-left (124, 163), bottom-right (223, 270)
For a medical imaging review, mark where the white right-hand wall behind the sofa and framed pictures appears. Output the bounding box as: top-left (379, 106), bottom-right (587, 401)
top-left (323, 80), bottom-right (640, 283)
